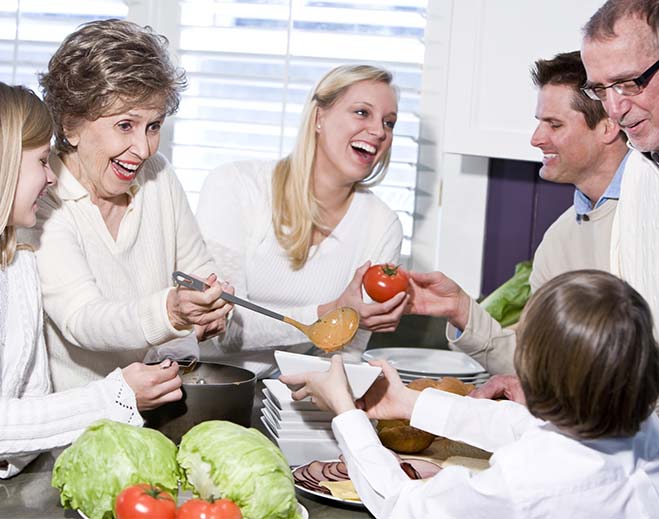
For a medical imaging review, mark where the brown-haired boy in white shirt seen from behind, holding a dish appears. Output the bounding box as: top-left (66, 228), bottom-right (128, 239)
top-left (282, 270), bottom-right (659, 519)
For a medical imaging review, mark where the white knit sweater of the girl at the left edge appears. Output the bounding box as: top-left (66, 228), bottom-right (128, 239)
top-left (0, 251), bottom-right (142, 478)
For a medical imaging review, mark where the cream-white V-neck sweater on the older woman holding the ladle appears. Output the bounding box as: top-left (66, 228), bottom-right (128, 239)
top-left (20, 155), bottom-right (217, 391)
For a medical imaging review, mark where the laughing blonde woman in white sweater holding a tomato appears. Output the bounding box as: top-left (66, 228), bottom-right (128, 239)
top-left (197, 65), bottom-right (407, 376)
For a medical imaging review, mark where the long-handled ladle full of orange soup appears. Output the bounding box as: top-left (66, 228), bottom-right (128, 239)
top-left (172, 271), bottom-right (359, 352)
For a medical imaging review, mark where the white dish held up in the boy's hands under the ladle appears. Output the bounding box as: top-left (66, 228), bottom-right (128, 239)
top-left (275, 351), bottom-right (382, 398)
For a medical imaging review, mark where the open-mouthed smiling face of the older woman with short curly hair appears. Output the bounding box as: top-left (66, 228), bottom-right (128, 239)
top-left (63, 104), bottom-right (165, 200)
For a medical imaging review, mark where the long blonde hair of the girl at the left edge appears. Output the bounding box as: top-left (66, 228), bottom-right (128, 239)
top-left (0, 82), bottom-right (53, 270)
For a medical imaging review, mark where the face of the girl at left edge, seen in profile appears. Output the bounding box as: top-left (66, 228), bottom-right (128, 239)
top-left (9, 144), bottom-right (56, 227)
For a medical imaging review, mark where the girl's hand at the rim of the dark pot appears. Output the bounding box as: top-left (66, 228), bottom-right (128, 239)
top-left (121, 359), bottom-right (183, 411)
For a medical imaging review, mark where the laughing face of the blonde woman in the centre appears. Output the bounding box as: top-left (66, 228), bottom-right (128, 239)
top-left (315, 81), bottom-right (398, 185)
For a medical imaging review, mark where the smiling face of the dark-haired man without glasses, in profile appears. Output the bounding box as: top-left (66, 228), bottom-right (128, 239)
top-left (531, 84), bottom-right (605, 185)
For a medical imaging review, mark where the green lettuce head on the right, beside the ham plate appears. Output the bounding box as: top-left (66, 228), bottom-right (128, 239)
top-left (178, 420), bottom-right (299, 519)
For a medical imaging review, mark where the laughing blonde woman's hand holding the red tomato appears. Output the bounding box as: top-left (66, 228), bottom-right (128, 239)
top-left (318, 261), bottom-right (409, 332)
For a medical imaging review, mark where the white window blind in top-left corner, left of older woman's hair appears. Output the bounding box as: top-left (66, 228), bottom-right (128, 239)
top-left (0, 0), bottom-right (128, 92)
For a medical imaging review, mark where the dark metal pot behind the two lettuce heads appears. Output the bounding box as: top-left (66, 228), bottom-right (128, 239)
top-left (142, 362), bottom-right (256, 444)
